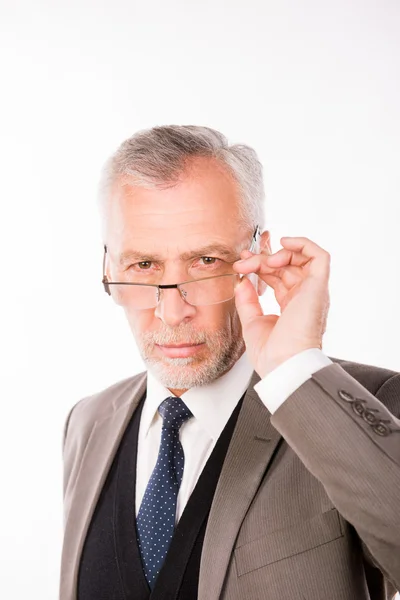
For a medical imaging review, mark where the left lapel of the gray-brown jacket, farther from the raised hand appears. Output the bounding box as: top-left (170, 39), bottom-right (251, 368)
top-left (60, 375), bottom-right (146, 600)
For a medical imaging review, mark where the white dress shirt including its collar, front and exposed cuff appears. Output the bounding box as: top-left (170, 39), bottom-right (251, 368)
top-left (135, 348), bottom-right (332, 521)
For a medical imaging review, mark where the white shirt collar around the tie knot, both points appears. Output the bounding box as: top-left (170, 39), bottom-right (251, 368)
top-left (141, 352), bottom-right (253, 440)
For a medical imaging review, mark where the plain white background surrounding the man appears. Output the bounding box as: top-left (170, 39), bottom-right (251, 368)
top-left (0, 0), bottom-right (400, 600)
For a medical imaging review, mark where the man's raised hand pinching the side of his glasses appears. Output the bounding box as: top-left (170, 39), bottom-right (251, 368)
top-left (233, 237), bottom-right (330, 378)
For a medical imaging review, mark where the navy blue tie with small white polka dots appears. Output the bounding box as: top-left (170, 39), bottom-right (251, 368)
top-left (136, 396), bottom-right (193, 589)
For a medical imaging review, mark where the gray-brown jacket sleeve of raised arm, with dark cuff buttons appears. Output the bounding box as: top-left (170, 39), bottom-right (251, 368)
top-left (271, 364), bottom-right (400, 590)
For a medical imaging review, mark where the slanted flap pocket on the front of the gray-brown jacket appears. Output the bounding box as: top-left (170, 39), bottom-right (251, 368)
top-left (235, 509), bottom-right (343, 576)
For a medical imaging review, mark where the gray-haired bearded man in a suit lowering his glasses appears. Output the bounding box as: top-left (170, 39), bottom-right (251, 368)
top-left (60, 126), bottom-right (400, 600)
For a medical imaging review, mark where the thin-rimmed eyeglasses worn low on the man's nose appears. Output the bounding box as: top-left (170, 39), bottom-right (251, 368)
top-left (102, 226), bottom-right (260, 310)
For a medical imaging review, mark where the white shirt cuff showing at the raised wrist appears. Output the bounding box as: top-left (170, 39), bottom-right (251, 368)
top-left (254, 348), bottom-right (332, 414)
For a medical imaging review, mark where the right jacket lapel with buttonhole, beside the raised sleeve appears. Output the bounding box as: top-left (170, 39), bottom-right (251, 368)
top-left (198, 374), bottom-right (282, 600)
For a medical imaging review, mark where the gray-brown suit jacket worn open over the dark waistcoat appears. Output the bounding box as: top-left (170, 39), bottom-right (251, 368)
top-left (60, 358), bottom-right (400, 600)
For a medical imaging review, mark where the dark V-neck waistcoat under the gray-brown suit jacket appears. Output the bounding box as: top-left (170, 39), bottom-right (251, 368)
top-left (77, 397), bottom-right (243, 600)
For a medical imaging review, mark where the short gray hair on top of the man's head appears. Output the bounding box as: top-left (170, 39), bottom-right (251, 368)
top-left (99, 125), bottom-right (265, 231)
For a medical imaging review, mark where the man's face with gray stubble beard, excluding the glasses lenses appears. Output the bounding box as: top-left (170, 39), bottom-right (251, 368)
top-left (106, 159), bottom-right (251, 393)
